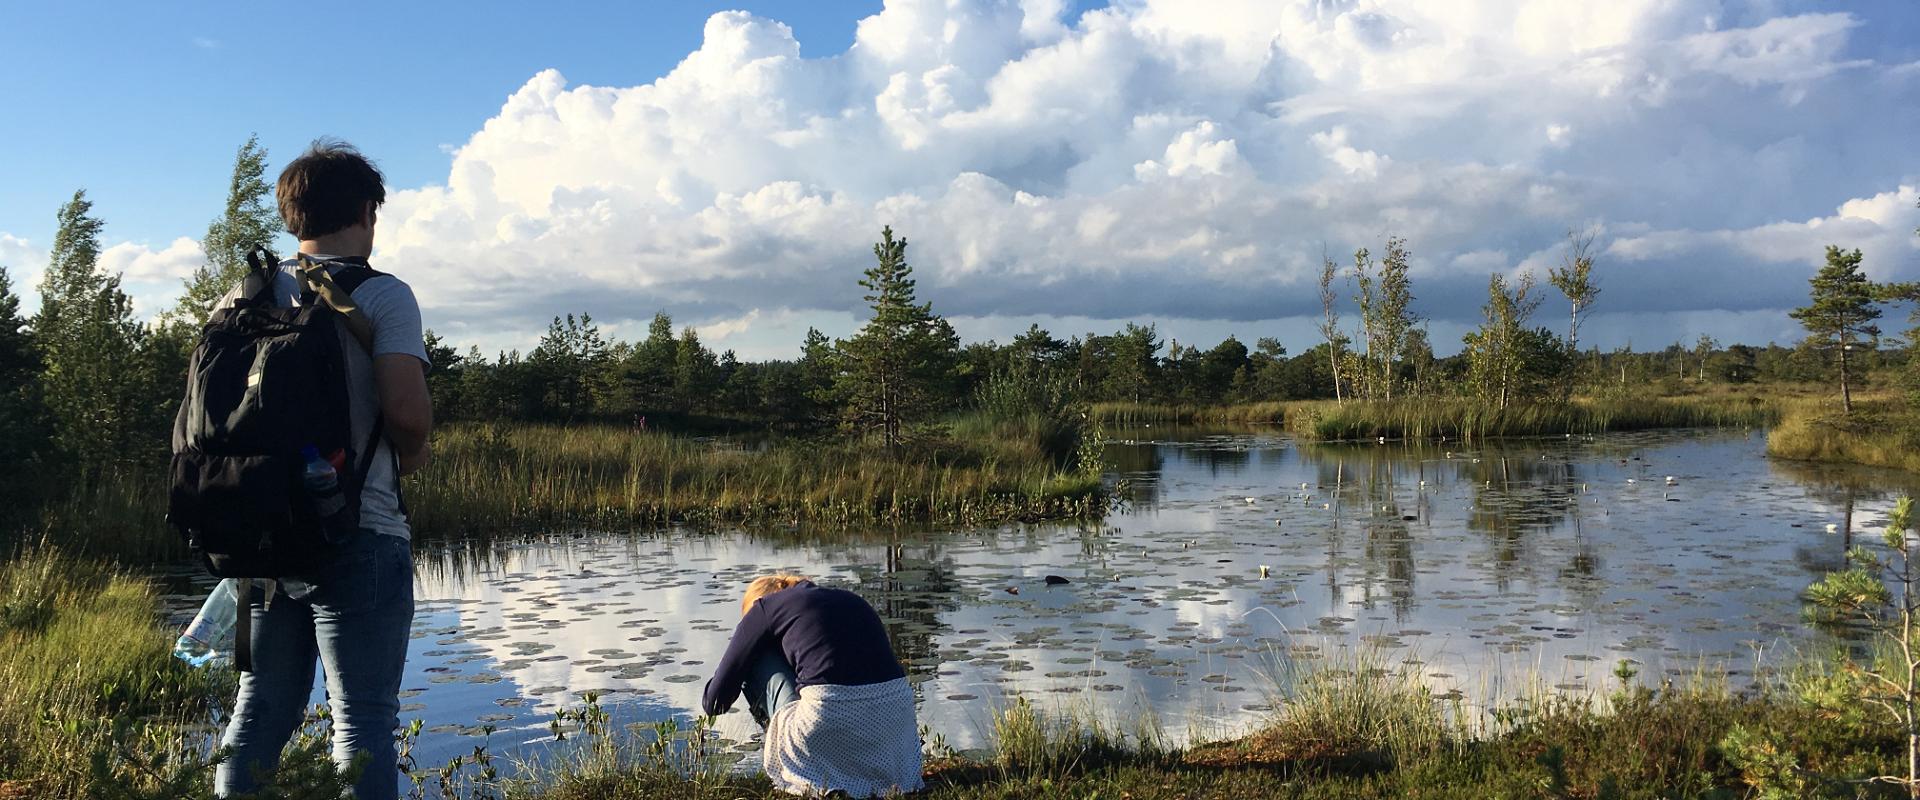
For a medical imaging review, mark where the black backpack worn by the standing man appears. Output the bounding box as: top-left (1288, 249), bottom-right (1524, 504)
top-left (167, 247), bottom-right (382, 583)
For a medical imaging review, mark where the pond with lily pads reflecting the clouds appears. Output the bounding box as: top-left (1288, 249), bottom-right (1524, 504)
top-left (161, 428), bottom-right (1914, 782)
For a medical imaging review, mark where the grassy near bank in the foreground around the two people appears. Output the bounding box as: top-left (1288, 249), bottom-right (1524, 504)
top-left (0, 551), bottom-right (1905, 800)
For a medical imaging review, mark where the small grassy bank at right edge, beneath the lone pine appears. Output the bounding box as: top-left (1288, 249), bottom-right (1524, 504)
top-left (1766, 395), bottom-right (1920, 472)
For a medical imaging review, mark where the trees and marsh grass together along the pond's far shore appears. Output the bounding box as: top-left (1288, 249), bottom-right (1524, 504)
top-left (0, 140), bottom-right (1920, 558)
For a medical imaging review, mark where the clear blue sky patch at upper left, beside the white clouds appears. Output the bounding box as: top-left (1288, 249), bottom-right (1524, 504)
top-left (0, 0), bottom-right (913, 242)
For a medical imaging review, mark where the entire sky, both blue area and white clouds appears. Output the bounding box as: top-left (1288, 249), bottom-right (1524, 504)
top-left (0, 0), bottom-right (1920, 359)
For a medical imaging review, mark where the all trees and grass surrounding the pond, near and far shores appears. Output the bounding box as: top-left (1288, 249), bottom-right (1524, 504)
top-left (0, 140), bottom-right (1920, 798)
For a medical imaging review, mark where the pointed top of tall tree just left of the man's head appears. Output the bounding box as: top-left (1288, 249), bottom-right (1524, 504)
top-left (161, 134), bottom-right (280, 328)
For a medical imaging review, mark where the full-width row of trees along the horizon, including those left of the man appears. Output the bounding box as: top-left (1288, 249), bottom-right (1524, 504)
top-left (0, 138), bottom-right (1914, 514)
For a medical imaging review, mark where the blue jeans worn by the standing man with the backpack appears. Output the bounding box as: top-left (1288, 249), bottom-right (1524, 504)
top-left (215, 529), bottom-right (413, 800)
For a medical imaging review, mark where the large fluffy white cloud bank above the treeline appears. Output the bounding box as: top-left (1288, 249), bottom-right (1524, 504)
top-left (15, 0), bottom-right (1920, 355)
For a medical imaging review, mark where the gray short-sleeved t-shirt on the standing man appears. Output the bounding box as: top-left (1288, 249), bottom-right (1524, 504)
top-left (221, 253), bottom-right (432, 539)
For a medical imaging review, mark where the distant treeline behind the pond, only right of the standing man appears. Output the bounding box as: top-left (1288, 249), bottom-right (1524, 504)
top-left (428, 230), bottom-right (1907, 435)
